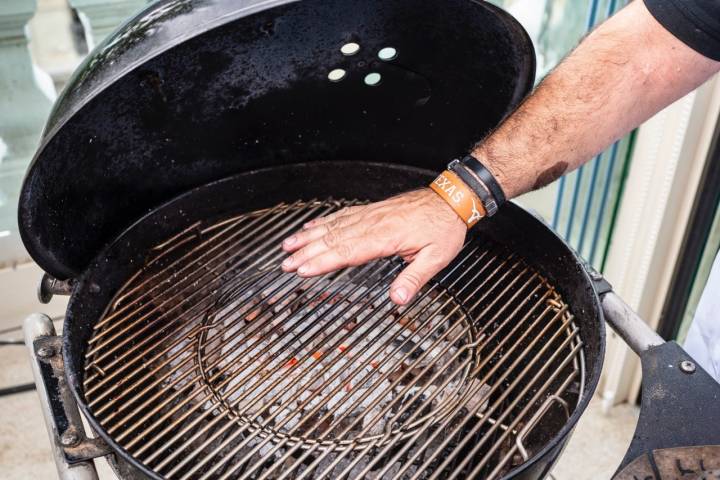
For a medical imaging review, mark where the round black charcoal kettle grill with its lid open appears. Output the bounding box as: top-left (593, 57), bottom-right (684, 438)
top-left (19, 0), bottom-right (720, 480)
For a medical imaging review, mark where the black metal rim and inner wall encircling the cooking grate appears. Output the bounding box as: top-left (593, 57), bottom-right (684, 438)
top-left (63, 162), bottom-right (605, 480)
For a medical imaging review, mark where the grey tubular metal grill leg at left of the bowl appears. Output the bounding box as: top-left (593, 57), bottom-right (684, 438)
top-left (23, 314), bottom-right (98, 480)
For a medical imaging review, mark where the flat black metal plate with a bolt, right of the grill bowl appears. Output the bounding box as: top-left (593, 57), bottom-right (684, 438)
top-left (620, 342), bottom-right (720, 472)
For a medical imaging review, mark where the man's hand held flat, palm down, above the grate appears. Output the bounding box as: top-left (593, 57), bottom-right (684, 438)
top-left (282, 188), bottom-right (467, 305)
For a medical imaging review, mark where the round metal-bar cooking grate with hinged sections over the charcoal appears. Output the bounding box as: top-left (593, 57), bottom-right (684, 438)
top-left (84, 200), bottom-right (584, 479)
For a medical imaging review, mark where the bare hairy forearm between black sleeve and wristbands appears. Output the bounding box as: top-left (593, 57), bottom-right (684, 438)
top-left (473, 0), bottom-right (720, 198)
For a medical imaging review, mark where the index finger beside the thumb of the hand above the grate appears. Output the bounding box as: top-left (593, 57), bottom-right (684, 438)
top-left (297, 237), bottom-right (387, 277)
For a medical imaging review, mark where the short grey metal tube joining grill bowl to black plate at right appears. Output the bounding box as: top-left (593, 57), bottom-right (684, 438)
top-left (600, 291), bottom-right (665, 355)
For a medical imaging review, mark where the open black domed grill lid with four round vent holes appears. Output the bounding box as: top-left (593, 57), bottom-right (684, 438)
top-left (19, 0), bottom-right (535, 278)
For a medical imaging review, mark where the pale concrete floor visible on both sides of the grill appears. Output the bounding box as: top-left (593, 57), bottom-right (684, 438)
top-left (0, 320), bottom-right (638, 480)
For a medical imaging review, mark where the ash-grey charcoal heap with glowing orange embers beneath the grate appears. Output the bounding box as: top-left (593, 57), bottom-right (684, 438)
top-left (162, 281), bottom-right (487, 480)
